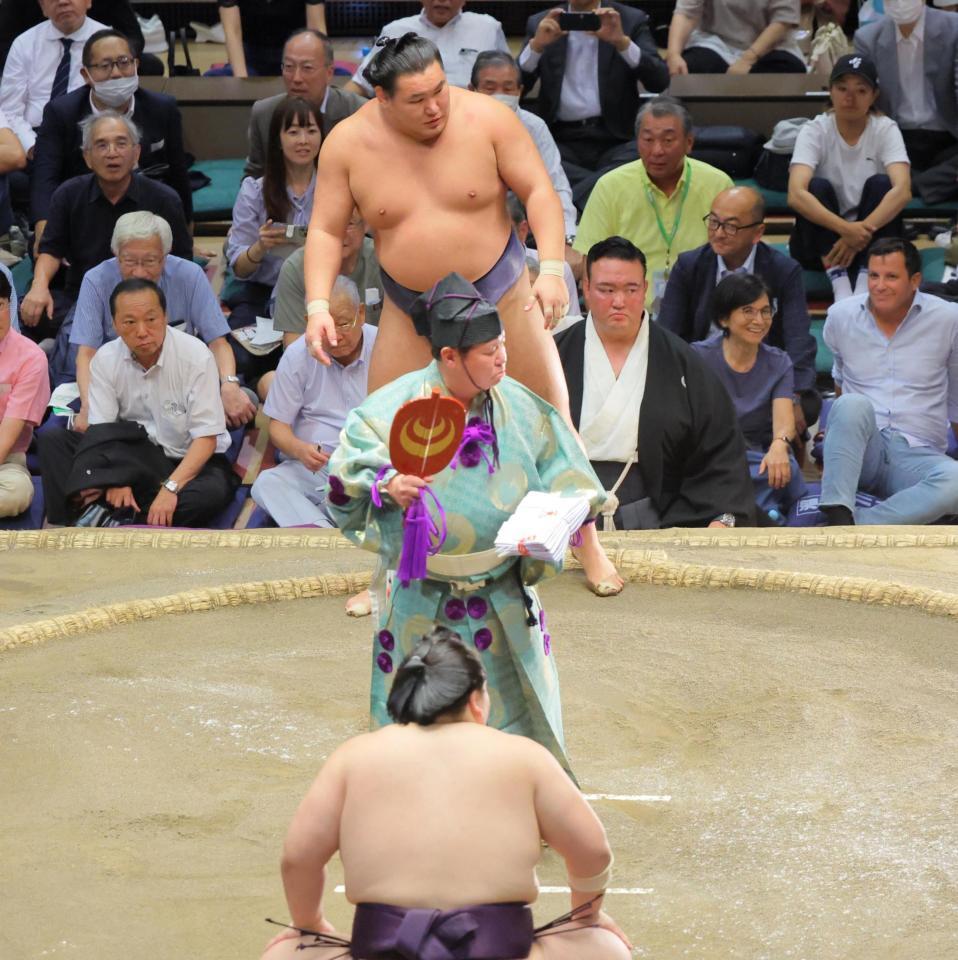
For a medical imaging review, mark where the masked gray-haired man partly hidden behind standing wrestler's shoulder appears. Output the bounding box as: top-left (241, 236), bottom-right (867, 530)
top-left (469, 50), bottom-right (582, 263)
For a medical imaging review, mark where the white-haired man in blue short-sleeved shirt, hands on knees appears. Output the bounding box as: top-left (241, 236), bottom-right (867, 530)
top-left (65, 218), bottom-right (256, 431)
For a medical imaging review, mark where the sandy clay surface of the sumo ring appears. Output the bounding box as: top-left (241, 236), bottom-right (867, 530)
top-left (0, 547), bottom-right (958, 960)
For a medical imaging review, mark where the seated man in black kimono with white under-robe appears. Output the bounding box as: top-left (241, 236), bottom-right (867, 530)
top-left (556, 237), bottom-right (755, 530)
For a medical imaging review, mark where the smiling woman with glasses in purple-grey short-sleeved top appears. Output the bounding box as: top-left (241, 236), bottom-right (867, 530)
top-left (692, 273), bottom-right (806, 516)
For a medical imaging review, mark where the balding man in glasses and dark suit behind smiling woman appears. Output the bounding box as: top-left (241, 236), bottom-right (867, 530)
top-left (656, 187), bottom-right (822, 436)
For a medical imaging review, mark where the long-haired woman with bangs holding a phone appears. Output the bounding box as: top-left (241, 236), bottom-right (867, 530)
top-left (223, 97), bottom-right (323, 378)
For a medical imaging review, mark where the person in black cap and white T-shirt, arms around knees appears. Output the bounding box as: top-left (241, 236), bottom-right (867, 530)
top-left (788, 54), bottom-right (911, 300)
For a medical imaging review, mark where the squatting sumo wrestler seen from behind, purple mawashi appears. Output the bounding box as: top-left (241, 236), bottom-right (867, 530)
top-left (263, 627), bottom-right (630, 960)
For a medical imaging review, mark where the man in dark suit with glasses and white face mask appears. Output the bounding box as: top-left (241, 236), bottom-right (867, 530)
top-left (30, 30), bottom-right (193, 245)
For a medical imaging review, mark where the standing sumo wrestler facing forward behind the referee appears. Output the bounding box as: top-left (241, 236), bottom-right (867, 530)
top-left (305, 34), bottom-right (622, 596)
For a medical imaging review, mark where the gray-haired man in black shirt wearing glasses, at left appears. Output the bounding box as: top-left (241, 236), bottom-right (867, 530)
top-left (20, 110), bottom-right (193, 340)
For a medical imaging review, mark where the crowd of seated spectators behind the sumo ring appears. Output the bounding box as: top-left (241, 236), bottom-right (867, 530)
top-left (0, 0), bottom-right (958, 528)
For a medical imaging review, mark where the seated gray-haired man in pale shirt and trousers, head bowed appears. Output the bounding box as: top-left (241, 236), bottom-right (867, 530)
top-left (251, 275), bottom-right (376, 527)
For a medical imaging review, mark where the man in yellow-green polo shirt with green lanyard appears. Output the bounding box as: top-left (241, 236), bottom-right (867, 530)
top-left (575, 97), bottom-right (732, 315)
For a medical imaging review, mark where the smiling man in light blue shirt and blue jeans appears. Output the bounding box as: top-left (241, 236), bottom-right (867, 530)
top-left (821, 238), bottom-right (958, 525)
